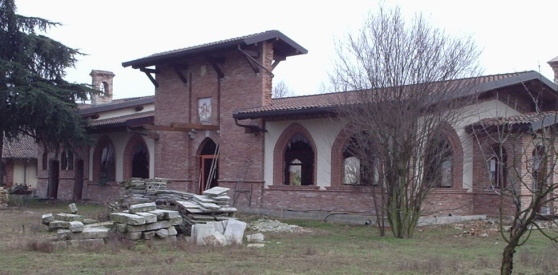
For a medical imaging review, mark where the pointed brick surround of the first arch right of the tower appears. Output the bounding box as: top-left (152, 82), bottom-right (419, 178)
top-left (273, 123), bottom-right (318, 185)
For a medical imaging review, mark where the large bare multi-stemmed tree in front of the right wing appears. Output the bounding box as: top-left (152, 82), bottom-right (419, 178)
top-left (330, 3), bottom-right (479, 238)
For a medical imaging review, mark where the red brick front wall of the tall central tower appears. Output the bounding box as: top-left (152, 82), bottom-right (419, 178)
top-left (151, 43), bottom-right (273, 194)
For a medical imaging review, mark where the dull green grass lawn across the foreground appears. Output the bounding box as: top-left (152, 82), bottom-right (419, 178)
top-left (0, 201), bottom-right (558, 275)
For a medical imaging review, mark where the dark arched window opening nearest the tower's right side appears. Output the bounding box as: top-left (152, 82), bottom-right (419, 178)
top-left (284, 132), bottom-right (314, 185)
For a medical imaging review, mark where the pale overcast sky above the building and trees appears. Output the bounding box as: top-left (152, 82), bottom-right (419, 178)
top-left (15, 0), bottom-right (558, 98)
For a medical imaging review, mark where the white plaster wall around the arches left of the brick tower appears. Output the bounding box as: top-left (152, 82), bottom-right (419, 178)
top-left (88, 132), bottom-right (155, 181)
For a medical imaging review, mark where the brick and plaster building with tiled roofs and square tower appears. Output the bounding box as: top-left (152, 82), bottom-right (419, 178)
top-left (38, 31), bottom-right (558, 218)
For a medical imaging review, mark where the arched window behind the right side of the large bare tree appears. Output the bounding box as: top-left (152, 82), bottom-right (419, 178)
top-left (425, 134), bottom-right (454, 188)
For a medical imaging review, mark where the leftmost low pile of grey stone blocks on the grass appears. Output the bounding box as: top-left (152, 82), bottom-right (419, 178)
top-left (41, 203), bottom-right (112, 249)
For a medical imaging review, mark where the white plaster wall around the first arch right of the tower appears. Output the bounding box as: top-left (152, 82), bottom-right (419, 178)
top-left (264, 118), bottom-right (343, 188)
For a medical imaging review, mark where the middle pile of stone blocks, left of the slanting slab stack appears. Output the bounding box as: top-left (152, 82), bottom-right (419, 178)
top-left (110, 202), bottom-right (183, 240)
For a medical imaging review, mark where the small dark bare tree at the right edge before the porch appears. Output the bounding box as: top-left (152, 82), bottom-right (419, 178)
top-left (470, 105), bottom-right (558, 274)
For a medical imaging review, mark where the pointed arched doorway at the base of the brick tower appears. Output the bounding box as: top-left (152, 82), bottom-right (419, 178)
top-left (198, 138), bottom-right (219, 194)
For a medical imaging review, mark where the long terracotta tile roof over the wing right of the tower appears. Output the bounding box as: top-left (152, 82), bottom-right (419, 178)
top-left (234, 71), bottom-right (556, 119)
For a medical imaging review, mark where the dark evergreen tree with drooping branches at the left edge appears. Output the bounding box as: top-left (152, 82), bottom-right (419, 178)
top-left (0, 0), bottom-right (94, 185)
